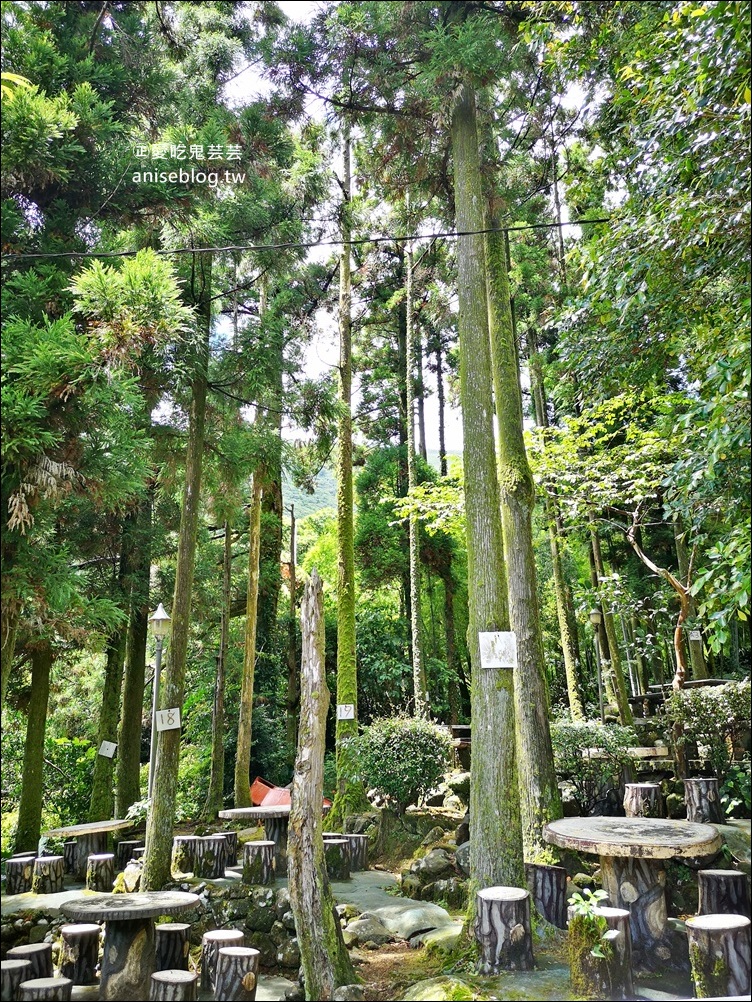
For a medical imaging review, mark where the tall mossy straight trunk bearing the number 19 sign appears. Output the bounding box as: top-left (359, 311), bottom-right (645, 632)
top-left (332, 119), bottom-right (367, 824)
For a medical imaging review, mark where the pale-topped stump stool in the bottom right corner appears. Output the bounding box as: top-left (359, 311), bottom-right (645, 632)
top-left (687, 915), bottom-right (750, 999)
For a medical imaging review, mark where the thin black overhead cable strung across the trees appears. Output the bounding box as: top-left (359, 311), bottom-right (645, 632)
top-left (2, 215), bottom-right (613, 265)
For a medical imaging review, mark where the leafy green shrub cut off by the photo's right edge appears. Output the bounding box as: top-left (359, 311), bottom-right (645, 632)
top-left (665, 678), bottom-right (750, 783)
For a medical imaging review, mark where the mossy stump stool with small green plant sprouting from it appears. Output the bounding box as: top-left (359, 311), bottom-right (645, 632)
top-left (567, 905), bottom-right (635, 999)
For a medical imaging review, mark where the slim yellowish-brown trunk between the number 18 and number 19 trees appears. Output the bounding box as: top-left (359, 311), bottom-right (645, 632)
top-left (235, 471), bottom-right (263, 808)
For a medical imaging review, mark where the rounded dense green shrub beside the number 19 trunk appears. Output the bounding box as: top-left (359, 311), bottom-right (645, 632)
top-left (353, 716), bottom-right (451, 815)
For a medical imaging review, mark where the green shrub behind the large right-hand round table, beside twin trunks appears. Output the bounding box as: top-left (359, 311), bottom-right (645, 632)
top-left (550, 721), bottom-right (637, 816)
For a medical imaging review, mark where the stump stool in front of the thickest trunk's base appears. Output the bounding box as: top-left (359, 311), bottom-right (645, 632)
top-left (475, 887), bottom-right (533, 974)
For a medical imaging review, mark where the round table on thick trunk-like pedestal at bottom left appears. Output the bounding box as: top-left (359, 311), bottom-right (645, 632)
top-left (60, 891), bottom-right (199, 1002)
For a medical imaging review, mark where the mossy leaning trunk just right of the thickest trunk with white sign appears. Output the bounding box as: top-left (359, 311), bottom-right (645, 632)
top-left (486, 212), bottom-right (561, 862)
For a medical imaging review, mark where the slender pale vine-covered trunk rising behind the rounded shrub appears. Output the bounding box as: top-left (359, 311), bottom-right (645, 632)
top-left (405, 213), bottom-right (428, 716)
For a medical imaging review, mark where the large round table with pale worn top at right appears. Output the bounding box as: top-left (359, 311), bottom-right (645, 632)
top-left (543, 818), bottom-right (721, 968)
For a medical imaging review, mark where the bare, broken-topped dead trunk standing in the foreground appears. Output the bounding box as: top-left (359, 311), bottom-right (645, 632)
top-left (288, 568), bottom-right (355, 999)
